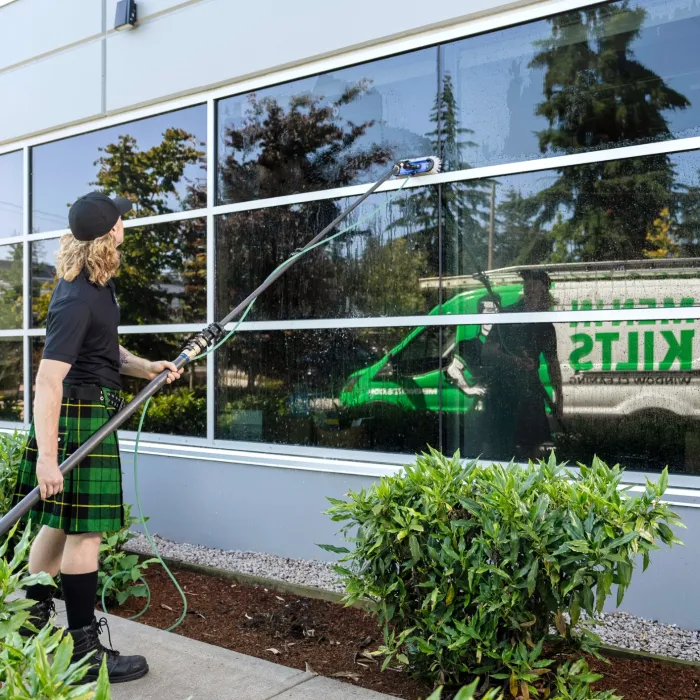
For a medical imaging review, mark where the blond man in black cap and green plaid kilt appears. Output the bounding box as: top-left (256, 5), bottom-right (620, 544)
top-left (14, 192), bottom-right (181, 683)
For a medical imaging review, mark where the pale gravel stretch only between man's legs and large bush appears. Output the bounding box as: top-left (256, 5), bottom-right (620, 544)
top-left (126, 534), bottom-right (344, 593)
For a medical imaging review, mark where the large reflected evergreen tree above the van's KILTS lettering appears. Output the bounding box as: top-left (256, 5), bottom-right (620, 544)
top-left (531, 2), bottom-right (690, 261)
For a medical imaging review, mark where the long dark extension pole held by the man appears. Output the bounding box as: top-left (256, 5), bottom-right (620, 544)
top-left (0, 165), bottom-right (400, 537)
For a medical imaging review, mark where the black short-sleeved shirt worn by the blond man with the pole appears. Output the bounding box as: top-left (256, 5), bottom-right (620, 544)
top-left (43, 270), bottom-right (121, 389)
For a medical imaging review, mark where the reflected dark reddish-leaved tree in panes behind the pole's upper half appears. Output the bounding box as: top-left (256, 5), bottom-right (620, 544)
top-left (216, 81), bottom-right (392, 388)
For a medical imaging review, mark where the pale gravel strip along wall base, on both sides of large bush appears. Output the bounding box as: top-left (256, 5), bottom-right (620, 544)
top-left (127, 535), bottom-right (700, 662)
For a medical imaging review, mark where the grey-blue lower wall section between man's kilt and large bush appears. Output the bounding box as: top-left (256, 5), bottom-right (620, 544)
top-left (122, 452), bottom-right (372, 559)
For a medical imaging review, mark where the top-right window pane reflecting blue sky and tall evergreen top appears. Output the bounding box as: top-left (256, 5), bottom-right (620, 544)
top-left (441, 0), bottom-right (700, 170)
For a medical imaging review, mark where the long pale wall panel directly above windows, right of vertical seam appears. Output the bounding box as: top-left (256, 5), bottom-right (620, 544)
top-left (107, 0), bottom-right (532, 110)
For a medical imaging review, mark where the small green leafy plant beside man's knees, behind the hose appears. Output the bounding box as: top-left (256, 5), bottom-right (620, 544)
top-left (97, 504), bottom-right (158, 605)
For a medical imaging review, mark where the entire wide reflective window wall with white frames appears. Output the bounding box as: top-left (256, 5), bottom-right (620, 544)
top-left (0, 0), bottom-right (700, 474)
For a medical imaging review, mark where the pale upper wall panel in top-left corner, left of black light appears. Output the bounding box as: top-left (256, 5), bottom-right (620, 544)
top-left (0, 0), bottom-right (102, 69)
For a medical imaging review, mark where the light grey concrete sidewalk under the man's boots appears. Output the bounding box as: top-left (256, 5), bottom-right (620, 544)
top-left (51, 600), bottom-right (392, 700)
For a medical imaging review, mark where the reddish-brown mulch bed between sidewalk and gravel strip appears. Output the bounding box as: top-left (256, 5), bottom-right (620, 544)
top-left (98, 566), bottom-right (700, 700)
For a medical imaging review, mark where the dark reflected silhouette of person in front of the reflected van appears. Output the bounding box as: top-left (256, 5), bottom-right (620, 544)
top-left (482, 270), bottom-right (563, 460)
